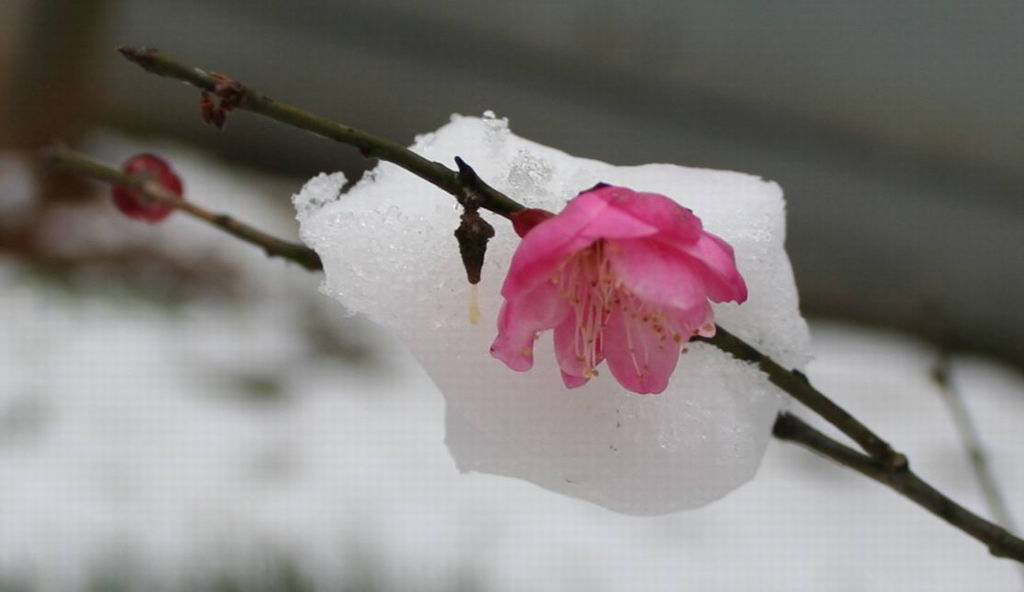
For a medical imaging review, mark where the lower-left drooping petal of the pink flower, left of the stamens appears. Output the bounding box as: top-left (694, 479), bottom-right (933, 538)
top-left (490, 282), bottom-right (570, 372)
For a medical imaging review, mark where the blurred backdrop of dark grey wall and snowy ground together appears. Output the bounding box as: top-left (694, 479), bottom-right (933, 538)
top-left (0, 0), bottom-right (1024, 590)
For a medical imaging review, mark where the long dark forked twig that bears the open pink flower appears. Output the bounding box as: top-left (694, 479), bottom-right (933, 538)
top-left (105, 47), bottom-right (1024, 563)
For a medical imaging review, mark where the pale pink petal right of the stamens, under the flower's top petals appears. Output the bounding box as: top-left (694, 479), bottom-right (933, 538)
top-left (604, 239), bottom-right (708, 310)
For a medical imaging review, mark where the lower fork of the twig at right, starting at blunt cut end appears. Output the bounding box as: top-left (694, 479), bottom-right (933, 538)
top-left (772, 413), bottom-right (1024, 562)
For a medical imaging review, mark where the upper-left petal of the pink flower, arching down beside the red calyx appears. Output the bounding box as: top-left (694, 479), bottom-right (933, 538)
top-left (502, 192), bottom-right (657, 298)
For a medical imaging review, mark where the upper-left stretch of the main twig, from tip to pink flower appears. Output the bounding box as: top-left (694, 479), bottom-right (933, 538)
top-left (118, 47), bottom-right (524, 218)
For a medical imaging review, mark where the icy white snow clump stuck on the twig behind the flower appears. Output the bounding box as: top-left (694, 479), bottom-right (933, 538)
top-left (295, 113), bottom-right (808, 514)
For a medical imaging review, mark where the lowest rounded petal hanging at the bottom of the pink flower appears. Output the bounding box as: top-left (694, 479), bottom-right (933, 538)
top-left (604, 308), bottom-right (680, 394)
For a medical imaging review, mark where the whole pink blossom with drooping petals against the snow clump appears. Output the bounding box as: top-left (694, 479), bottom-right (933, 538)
top-left (490, 183), bottom-right (746, 394)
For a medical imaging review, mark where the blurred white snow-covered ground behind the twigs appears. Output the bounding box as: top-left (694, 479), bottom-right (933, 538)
top-left (0, 140), bottom-right (1024, 591)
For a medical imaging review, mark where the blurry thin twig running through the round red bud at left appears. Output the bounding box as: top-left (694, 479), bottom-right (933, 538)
top-left (46, 146), bottom-right (324, 271)
